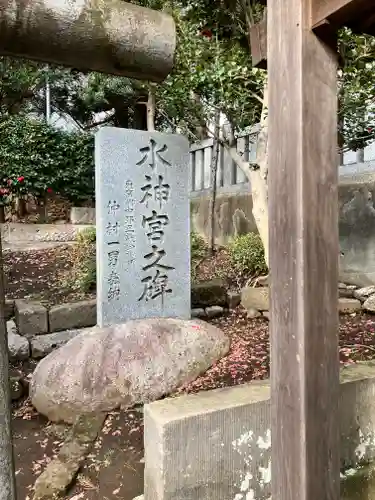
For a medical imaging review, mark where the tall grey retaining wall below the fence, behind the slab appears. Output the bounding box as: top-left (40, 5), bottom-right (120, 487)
top-left (191, 172), bottom-right (375, 286)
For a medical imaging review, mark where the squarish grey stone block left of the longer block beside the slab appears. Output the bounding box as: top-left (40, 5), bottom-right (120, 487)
top-left (15, 300), bottom-right (48, 338)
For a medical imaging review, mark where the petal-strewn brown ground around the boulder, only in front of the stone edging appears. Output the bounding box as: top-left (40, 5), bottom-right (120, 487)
top-left (13, 310), bottom-right (375, 500)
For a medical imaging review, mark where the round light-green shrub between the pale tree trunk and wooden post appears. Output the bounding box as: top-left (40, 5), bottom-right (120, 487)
top-left (228, 233), bottom-right (267, 275)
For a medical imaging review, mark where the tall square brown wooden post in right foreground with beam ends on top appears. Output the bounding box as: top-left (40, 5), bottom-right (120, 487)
top-left (251, 0), bottom-right (375, 500)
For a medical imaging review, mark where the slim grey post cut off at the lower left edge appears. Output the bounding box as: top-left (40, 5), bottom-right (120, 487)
top-left (0, 231), bottom-right (16, 500)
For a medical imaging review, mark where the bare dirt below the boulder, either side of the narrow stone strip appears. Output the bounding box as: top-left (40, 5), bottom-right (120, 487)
top-left (13, 403), bottom-right (144, 500)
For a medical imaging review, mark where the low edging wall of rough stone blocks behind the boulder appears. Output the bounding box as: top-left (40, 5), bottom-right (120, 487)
top-left (5, 279), bottom-right (375, 361)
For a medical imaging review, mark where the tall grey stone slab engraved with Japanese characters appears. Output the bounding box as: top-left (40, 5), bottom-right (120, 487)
top-left (95, 127), bottom-right (190, 326)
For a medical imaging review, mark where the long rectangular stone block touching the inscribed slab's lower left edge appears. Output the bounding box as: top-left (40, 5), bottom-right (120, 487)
top-left (49, 299), bottom-right (96, 332)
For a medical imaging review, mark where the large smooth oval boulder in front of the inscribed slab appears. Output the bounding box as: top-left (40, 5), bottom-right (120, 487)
top-left (30, 319), bottom-right (229, 423)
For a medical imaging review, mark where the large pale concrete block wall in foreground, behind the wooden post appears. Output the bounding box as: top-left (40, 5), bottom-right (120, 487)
top-left (144, 362), bottom-right (375, 500)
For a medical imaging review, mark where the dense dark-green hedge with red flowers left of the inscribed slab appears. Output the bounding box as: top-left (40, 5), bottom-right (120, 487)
top-left (0, 115), bottom-right (95, 205)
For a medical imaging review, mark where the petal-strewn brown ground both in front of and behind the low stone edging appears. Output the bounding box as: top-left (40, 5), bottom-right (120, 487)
top-left (5, 247), bottom-right (375, 500)
